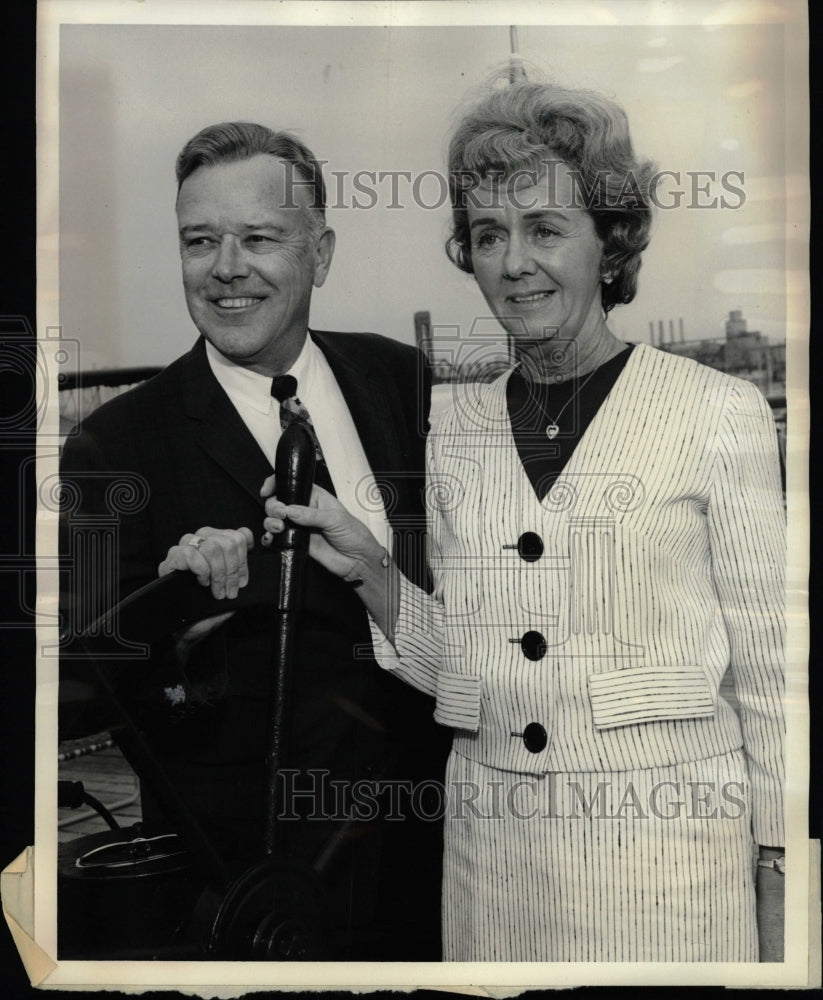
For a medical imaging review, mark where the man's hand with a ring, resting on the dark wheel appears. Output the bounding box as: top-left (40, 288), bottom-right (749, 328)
top-left (157, 528), bottom-right (254, 600)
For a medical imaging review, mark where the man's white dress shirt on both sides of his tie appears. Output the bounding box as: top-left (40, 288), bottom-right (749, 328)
top-left (206, 336), bottom-right (390, 547)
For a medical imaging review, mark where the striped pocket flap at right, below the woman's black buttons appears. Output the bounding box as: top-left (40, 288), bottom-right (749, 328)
top-left (588, 667), bottom-right (714, 729)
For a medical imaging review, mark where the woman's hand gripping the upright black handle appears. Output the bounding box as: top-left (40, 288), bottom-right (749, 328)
top-left (260, 476), bottom-right (385, 581)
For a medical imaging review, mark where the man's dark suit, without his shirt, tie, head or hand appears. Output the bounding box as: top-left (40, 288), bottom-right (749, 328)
top-left (62, 332), bottom-right (445, 958)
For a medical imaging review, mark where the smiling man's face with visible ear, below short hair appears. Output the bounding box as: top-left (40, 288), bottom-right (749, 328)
top-left (177, 154), bottom-right (334, 375)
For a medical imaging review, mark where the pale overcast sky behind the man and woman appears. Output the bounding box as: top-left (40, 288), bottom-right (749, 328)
top-left (50, 5), bottom-right (807, 367)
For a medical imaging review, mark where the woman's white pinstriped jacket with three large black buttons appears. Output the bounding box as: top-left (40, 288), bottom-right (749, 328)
top-left (374, 345), bottom-right (786, 844)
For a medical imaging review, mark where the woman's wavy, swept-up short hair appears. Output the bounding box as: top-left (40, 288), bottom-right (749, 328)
top-left (446, 82), bottom-right (654, 312)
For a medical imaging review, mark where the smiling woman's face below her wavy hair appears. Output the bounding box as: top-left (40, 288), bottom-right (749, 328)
top-left (468, 160), bottom-right (605, 349)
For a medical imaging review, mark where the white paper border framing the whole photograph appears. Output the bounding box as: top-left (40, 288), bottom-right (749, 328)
top-left (29, 0), bottom-right (810, 996)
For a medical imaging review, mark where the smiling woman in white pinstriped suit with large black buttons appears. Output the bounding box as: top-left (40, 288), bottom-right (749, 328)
top-left (265, 83), bottom-right (785, 961)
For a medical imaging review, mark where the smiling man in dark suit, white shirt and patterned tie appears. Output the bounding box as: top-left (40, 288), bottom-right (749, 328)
top-left (61, 123), bottom-right (445, 960)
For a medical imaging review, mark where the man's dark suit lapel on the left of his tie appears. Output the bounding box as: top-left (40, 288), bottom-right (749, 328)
top-left (183, 338), bottom-right (272, 503)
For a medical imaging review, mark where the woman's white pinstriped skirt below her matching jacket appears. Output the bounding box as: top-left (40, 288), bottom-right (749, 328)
top-left (443, 751), bottom-right (757, 962)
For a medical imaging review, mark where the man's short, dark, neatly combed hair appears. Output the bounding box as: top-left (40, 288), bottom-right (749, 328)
top-left (175, 122), bottom-right (326, 230)
